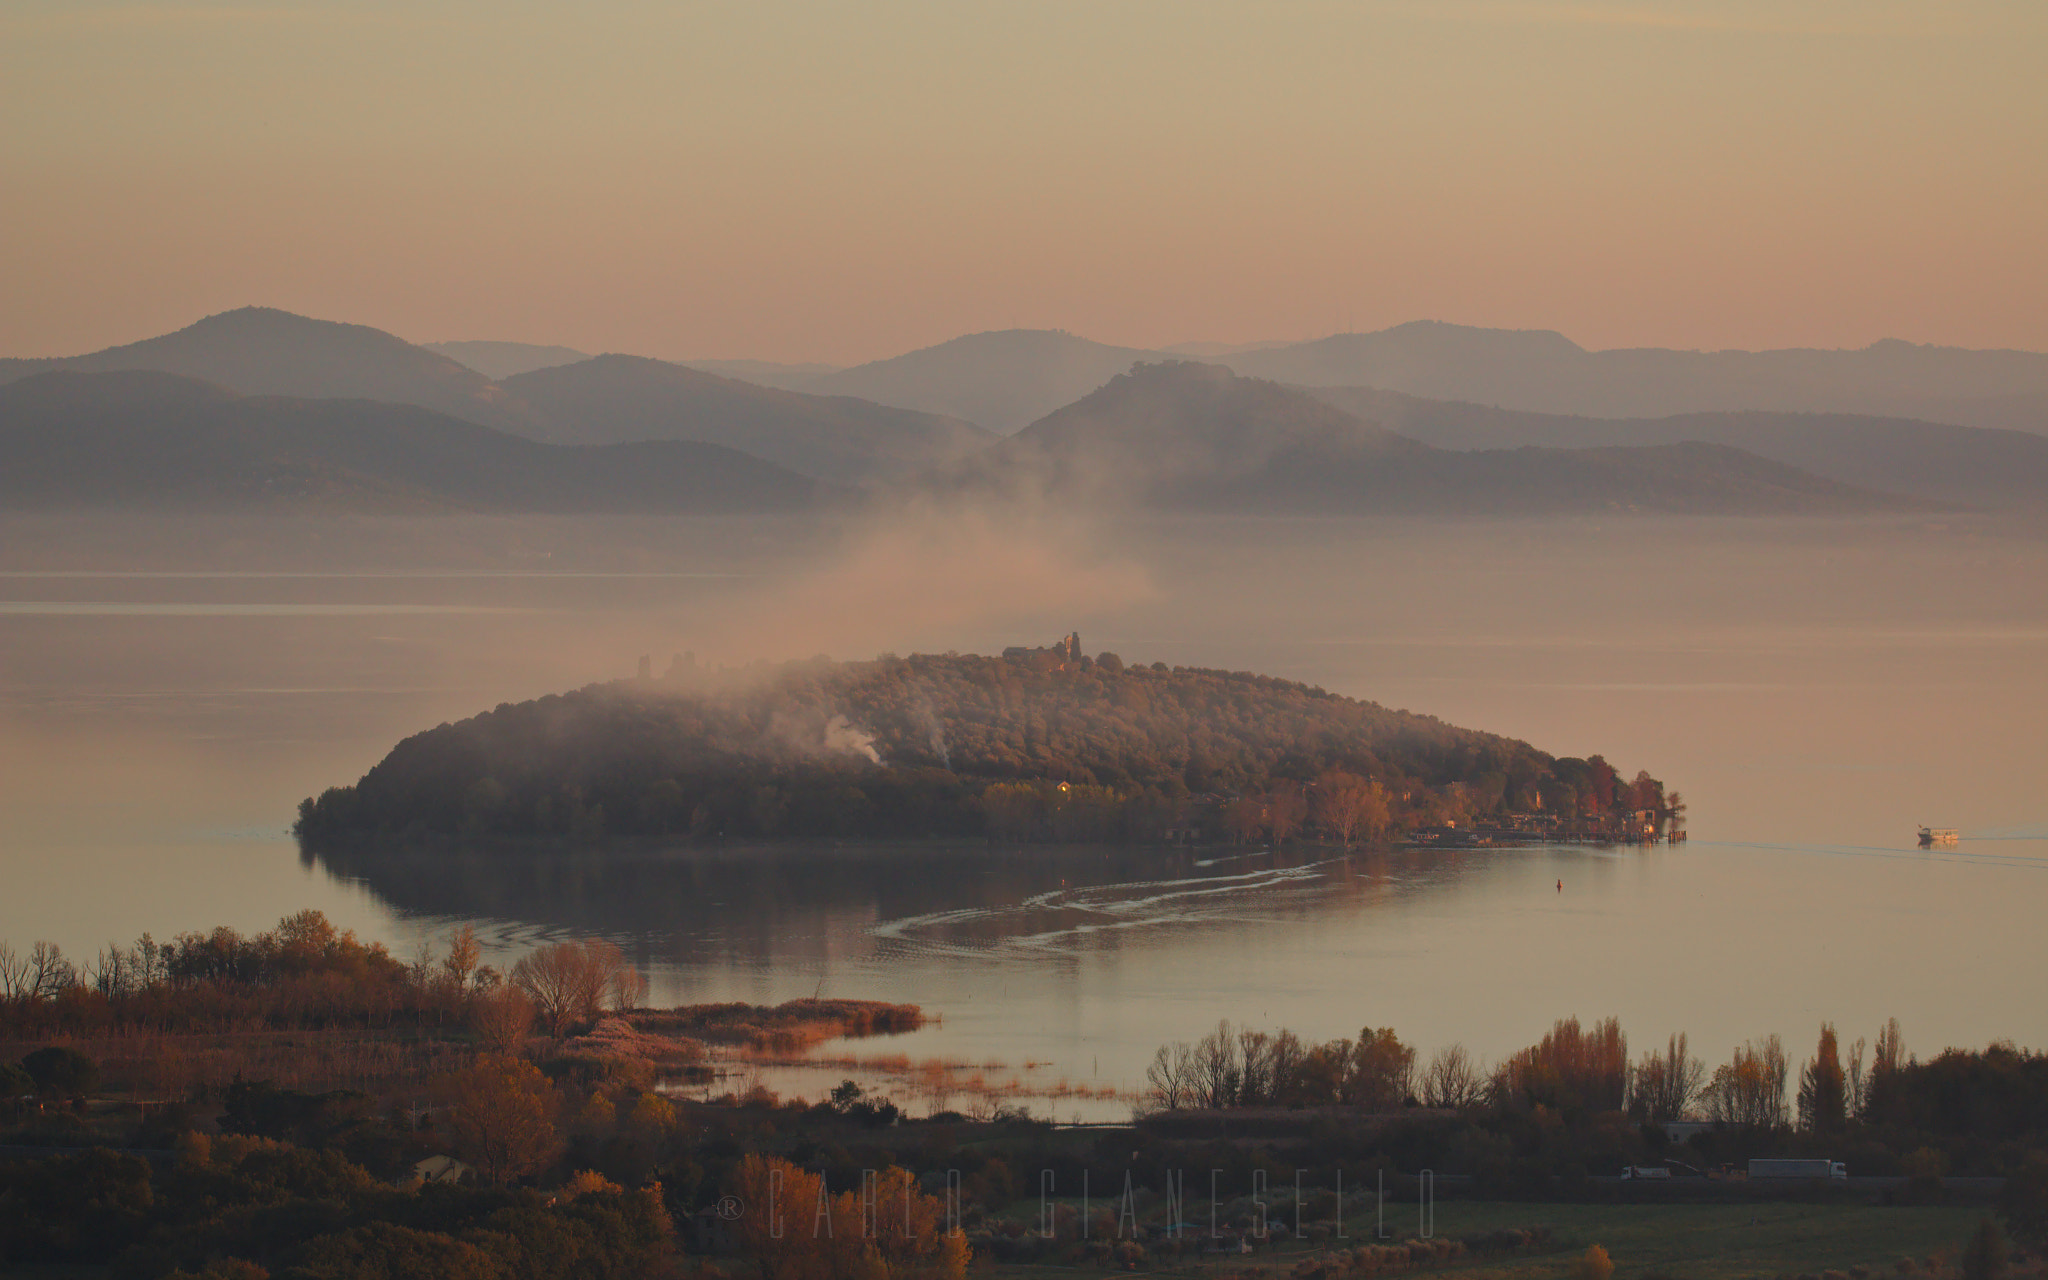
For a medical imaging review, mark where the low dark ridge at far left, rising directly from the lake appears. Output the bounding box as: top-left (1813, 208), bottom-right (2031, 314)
top-left (0, 371), bottom-right (821, 512)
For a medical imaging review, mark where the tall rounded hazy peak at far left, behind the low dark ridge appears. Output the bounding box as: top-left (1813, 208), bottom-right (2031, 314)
top-left (0, 307), bottom-right (530, 430)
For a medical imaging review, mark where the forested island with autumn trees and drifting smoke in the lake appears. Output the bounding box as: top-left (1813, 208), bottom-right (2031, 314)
top-left (297, 641), bottom-right (1663, 846)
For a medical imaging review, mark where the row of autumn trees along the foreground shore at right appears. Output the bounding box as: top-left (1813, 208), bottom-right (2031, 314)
top-left (1139, 1018), bottom-right (2048, 1179)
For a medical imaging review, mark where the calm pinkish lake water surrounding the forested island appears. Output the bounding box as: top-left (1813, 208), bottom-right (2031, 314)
top-left (0, 520), bottom-right (2048, 1118)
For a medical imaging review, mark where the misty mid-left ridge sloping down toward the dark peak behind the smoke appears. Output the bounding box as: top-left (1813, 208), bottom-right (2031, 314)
top-left (504, 354), bottom-right (991, 481)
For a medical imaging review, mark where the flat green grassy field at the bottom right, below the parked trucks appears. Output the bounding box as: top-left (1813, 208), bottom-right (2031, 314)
top-left (993, 1200), bottom-right (1990, 1280)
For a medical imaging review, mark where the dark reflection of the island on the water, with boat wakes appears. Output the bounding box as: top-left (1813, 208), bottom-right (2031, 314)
top-left (301, 844), bottom-right (1466, 967)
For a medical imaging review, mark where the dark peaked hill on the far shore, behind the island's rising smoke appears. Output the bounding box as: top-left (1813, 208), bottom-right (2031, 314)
top-left (928, 360), bottom-right (1917, 516)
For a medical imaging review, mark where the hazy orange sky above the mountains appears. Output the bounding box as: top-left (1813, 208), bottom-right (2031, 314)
top-left (0, 0), bottom-right (2048, 362)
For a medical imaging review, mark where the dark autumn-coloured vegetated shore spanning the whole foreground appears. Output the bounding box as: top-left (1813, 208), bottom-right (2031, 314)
top-left (0, 911), bottom-right (2048, 1280)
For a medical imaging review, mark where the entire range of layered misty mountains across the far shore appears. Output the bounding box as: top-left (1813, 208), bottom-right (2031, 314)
top-left (0, 307), bottom-right (2048, 512)
